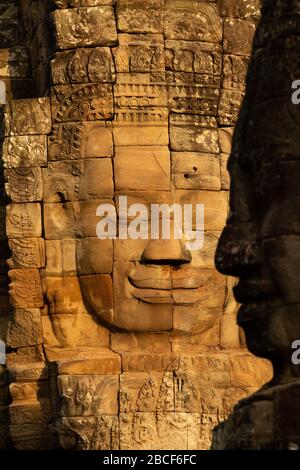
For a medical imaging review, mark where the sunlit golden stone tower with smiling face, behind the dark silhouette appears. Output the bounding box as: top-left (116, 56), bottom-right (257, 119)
top-left (0, 0), bottom-right (269, 449)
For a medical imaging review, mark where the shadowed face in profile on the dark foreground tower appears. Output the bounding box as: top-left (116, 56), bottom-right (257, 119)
top-left (216, 23), bottom-right (300, 375)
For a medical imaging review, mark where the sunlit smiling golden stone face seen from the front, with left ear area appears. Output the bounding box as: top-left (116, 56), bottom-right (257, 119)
top-left (44, 116), bottom-right (227, 333)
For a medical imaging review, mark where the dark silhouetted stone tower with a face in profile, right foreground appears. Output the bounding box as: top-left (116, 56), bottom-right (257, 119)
top-left (213, 0), bottom-right (300, 449)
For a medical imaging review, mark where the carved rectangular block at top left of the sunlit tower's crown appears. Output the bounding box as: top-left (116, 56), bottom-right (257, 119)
top-left (53, 6), bottom-right (117, 49)
